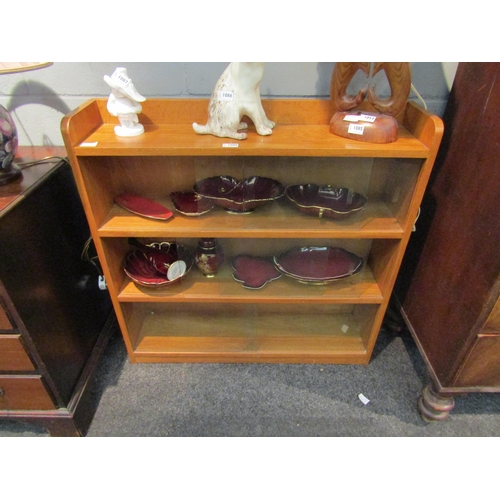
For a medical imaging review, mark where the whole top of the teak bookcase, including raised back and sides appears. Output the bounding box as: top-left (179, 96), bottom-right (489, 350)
top-left (63, 99), bottom-right (439, 159)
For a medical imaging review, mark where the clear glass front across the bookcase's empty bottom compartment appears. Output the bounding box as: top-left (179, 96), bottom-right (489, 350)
top-left (131, 298), bottom-right (376, 356)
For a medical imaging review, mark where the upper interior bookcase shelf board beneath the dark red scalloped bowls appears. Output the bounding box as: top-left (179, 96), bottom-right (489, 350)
top-left (99, 199), bottom-right (403, 238)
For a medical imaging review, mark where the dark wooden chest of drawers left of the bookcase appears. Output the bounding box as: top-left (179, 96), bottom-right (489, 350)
top-left (0, 147), bottom-right (113, 436)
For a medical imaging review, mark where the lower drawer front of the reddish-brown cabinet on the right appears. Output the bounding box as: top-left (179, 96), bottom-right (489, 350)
top-left (454, 334), bottom-right (500, 388)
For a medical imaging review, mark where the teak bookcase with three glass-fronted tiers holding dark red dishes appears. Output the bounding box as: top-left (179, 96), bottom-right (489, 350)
top-left (62, 99), bottom-right (443, 364)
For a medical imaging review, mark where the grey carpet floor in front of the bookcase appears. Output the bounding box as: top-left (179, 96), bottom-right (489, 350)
top-left (0, 330), bottom-right (500, 437)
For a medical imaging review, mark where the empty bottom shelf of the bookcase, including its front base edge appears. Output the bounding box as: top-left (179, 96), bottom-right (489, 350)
top-left (124, 306), bottom-right (376, 364)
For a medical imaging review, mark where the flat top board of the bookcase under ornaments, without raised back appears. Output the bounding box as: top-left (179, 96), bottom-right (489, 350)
top-left (75, 124), bottom-right (429, 158)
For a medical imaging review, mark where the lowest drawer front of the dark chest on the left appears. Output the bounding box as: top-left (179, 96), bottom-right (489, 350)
top-left (0, 375), bottom-right (56, 411)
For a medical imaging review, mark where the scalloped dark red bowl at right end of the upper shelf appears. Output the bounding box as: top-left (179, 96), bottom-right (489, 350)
top-left (285, 184), bottom-right (367, 219)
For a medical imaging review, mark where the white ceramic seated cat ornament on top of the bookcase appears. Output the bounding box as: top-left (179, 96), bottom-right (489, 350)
top-left (193, 62), bottom-right (275, 140)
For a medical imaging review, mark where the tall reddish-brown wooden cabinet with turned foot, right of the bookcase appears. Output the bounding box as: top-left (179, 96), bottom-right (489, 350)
top-left (395, 63), bottom-right (500, 420)
